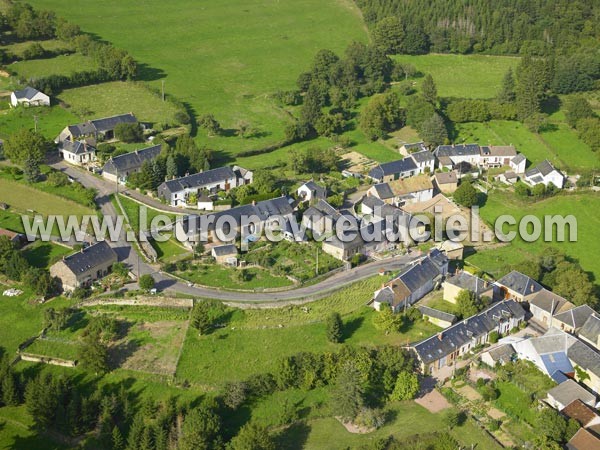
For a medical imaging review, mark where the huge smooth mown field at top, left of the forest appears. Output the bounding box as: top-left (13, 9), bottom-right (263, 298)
top-left (31, 0), bottom-right (367, 158)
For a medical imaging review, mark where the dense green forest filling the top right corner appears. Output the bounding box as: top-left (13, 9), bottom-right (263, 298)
top-left (356, 0), bottom-right (600, 55)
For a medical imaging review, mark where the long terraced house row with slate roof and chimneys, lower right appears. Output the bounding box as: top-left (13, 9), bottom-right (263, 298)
top-left (410, 300), bottom-right (525, 376)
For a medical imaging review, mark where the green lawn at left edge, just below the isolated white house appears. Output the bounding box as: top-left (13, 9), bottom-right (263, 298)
top-left (0, 104), bottom-right (79, 140)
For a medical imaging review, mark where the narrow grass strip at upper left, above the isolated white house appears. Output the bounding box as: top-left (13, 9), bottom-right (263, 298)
top-left (8, 53), bottom-right (98, 80)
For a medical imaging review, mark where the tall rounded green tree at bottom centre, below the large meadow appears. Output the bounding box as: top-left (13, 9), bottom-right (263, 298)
top-left (331, 361), bottom-right (364, 422)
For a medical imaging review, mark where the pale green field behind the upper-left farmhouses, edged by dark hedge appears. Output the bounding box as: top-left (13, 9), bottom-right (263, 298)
top-left (58, 81), bottom-right (176, 124)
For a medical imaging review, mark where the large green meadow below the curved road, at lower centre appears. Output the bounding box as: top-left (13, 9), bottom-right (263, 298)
top-left (177, 278), bottom-right (439, 386)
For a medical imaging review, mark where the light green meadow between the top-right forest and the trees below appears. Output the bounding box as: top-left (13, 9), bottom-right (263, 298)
top-left (393, 54), bottom-right (519, 98)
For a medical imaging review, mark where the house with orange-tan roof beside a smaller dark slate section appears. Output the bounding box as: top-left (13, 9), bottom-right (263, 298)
top-left (367, 174), bottom-right (433, 207)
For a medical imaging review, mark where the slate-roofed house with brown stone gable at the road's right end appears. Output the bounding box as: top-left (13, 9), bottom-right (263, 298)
top-left (371, 249), bottom-right (448, 312)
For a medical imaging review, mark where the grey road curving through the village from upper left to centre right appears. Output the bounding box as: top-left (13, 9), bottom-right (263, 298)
top-left (52, 161), bottom-right (419, 303)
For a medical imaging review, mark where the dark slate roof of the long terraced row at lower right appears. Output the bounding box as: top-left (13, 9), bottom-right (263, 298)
top-left (413, 300), bottom-right (525, 364)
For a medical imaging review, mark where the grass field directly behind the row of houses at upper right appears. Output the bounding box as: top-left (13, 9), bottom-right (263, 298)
top-left (455, 120), bottom-right (600, 170)
